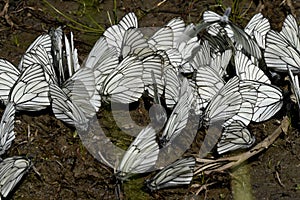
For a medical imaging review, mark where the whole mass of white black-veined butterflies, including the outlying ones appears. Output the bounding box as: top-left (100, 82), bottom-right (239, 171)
top-left (0, 5), bottom-right (300, 197)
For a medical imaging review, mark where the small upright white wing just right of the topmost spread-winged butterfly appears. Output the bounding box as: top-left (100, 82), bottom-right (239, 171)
top-left (244, 13), bottom-right (271, 49)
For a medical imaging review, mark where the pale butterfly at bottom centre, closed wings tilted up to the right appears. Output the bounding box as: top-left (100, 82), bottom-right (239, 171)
top-left (117, 125), bottom-right (159, 180)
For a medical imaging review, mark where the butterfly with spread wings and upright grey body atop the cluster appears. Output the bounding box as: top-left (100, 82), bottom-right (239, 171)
top-left (200, 8), bottom-right (261, 58)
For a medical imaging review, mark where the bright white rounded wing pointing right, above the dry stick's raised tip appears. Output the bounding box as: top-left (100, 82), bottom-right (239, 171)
top-left (239, 80), bottom-right (283, 122)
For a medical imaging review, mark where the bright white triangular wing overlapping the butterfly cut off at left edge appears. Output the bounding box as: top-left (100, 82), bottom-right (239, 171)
top-left (8, 64), bottom-right (50, 111)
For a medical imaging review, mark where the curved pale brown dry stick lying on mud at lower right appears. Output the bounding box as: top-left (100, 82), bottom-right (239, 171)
top-left (195, 116), bottom-right (290, 175)
